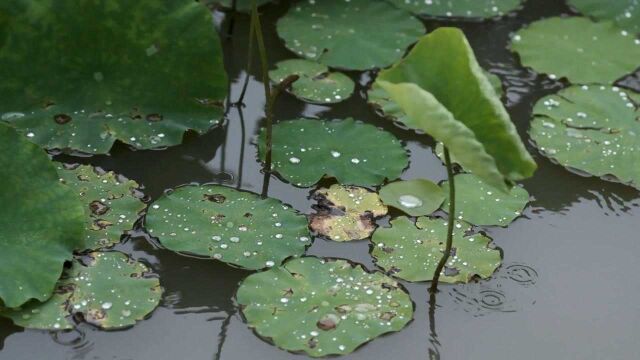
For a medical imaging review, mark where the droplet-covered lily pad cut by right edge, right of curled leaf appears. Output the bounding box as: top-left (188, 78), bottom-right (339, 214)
top-left (529, 85), bottom-right (640, 188)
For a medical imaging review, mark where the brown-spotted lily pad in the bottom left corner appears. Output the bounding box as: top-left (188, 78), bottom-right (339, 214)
top-left (0, 252), bottom-right (162, 330)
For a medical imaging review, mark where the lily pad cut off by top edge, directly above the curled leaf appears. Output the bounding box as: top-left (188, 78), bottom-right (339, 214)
top-left (387, 0), bottom-right (522, 19)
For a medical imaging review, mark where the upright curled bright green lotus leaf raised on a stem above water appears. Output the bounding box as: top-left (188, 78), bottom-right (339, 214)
top-left (376, 27), bottom-right (536, 191)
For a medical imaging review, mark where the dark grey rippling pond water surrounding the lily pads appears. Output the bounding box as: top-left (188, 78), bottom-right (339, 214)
top-left (0, 0), bottom-right (640, 360)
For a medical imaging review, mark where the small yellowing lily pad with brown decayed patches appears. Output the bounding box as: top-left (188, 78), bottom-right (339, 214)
top-left (309, 184), bottom-right (387, 241)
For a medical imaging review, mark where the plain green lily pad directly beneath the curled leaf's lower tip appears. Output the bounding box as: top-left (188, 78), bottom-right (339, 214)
top-left (441, 174), bottom-right (529, 226)
